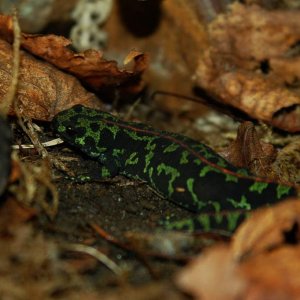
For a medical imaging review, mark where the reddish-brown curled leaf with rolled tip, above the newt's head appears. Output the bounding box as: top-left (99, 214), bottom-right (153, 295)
top-left (0, 15), bottom-right (148, 90)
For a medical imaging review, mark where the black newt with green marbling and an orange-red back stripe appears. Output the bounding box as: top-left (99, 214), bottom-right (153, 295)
top-left (53, 105), bottom-right (296, 231)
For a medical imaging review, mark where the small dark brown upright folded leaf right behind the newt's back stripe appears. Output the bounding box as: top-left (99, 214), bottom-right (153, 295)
top-left (224, 121), bottom-right (276, 177)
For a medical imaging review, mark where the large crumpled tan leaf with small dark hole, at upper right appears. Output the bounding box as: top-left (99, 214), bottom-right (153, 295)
top-left (195, 3), bottom-right (300, 132)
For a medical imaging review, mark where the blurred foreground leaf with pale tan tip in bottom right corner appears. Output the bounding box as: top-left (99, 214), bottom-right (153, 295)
top-left (176, 241), bottom-right (300, 300)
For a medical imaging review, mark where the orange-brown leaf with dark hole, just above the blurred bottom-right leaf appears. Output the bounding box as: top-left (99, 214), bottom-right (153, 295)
top-left (232, 198), bottom-right (300, 258)
